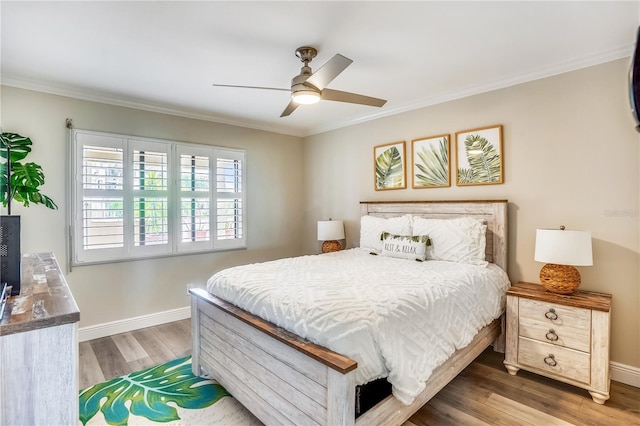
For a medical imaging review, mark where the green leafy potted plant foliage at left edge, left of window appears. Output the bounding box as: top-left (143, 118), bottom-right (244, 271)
top-left (0, 133), bottom-right (58, 213)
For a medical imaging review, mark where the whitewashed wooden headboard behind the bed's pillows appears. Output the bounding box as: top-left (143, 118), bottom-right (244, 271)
top-left (360, 200), bottom-right (507, 271)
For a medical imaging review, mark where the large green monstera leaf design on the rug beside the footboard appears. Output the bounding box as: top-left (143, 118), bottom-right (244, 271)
top-left (80, 357), bottom-right (230, 425)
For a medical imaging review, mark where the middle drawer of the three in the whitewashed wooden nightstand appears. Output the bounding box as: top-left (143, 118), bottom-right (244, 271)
top-left (518, 318), bottom-right (591, 352)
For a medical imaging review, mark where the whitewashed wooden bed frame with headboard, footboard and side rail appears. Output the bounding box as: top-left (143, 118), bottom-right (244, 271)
top-left (190, 200), bottom-right (507, 426)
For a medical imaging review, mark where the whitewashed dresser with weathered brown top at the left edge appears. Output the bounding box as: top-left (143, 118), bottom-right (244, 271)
top-left (0, 253), bottom-right (80, 426)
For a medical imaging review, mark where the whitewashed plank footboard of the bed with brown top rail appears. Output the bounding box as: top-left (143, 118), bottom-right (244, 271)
top-left (191, 289), bottom-right (357, 425)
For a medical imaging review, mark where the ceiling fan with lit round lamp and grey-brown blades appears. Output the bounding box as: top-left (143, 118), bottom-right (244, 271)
top-left (214, 46), bottom-right (387, 117)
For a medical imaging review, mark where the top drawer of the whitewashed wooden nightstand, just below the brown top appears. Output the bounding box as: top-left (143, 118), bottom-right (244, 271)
top-left (519, 298), bottom-right (591, 335)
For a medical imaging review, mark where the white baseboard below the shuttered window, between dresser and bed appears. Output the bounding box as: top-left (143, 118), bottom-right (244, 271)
top-left (79, 306), bottom-right (191, 342)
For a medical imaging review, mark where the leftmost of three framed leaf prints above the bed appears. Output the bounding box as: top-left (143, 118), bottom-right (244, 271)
top-left (373, 141), bottom-right (407, 191)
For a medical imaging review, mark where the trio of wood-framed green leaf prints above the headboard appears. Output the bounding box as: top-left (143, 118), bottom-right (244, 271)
top-left (373, 125), bottom-right (504, 191)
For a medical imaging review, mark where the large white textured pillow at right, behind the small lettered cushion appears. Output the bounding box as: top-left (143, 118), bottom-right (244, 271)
top-left (412, 216), bottom-right (488, 266)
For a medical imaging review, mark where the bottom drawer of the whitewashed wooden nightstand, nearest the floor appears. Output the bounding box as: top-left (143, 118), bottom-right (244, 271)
top-left (518, 337), bottom-right (591, 384)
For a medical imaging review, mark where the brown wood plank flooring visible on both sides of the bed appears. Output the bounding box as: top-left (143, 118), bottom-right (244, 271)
top-left (80, 319), bottom-right (640, 426)
